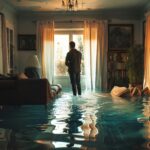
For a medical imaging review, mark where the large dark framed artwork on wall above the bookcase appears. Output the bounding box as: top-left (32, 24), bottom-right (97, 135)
top-left (108, 24), bottom-right (133, 51)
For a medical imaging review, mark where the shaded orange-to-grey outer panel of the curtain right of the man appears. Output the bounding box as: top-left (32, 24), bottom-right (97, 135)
top-left (95, 21), bottom-right (108, 91)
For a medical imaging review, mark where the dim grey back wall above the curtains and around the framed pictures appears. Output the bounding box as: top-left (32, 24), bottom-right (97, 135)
top-left (17, 12), bottom-right (143, 72)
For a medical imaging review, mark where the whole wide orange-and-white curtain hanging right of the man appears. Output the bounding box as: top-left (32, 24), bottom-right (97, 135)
top-left (84, 21), bottom-right (108, 90)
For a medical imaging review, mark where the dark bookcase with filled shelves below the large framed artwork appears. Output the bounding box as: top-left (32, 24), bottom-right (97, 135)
top-left (107, 51), bottom-right (128, 90)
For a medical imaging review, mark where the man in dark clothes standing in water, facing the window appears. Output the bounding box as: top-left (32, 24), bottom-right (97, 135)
top-left (65, 41), bottom-right (82, 96)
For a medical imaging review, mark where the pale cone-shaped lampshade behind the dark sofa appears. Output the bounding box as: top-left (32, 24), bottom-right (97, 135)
top-left (27, 55), bottom-right (41, 68)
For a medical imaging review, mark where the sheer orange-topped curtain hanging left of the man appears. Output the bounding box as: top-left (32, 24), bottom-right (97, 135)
top-left (37, 21), bottom-right (54, 83)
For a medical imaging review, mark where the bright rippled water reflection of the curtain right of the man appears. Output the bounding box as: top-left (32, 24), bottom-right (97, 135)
top-left (81, 94), bottom-right (99, 150)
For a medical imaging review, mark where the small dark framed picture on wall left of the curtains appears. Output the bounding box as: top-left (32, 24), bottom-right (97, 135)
top-left (18, 34), bottom-right (36, 51)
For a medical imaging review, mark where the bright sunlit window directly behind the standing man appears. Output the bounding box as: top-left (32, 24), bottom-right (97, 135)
top-left (54, 30), bottom-right (85, 76)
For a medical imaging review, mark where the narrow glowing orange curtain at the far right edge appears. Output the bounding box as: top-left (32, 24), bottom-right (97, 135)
top-left (143, 15), bottom-right (150, 89)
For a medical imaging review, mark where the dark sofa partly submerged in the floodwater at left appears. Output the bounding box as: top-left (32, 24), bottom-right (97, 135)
top-left (0, 79), bottom-right (61, 105)
